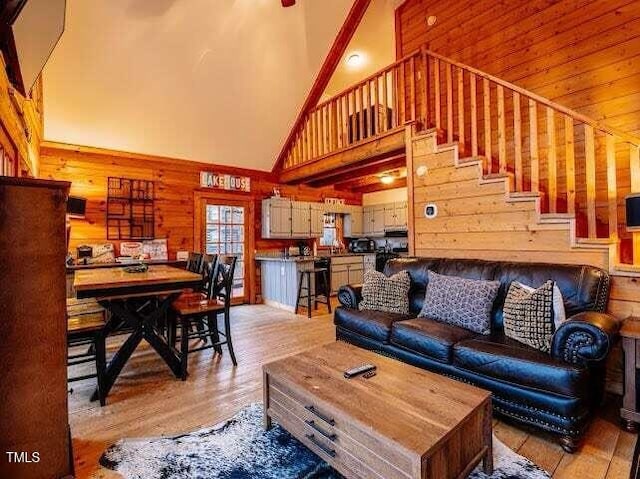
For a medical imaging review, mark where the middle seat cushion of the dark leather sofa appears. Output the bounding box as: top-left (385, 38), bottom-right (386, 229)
top-left (391, 318), bottom-right (476, 364)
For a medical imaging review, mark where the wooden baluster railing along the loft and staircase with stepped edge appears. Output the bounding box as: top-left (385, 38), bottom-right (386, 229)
top-left (281, 47), bottom-right (640, 275)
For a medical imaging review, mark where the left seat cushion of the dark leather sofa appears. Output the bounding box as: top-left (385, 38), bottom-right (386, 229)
top-left (333, 308), bottom-right (413, 343)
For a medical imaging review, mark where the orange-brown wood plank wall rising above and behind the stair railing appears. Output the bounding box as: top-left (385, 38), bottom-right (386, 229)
top-left (396, 0), bottom-right (640, 262)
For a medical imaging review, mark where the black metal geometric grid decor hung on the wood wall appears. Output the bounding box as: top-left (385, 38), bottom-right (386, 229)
top-left (107, 176), bottom-right (155, 240)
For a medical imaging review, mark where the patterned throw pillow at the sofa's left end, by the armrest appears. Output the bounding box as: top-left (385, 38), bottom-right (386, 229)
top-left (358, 271), bottom-right (411, 314)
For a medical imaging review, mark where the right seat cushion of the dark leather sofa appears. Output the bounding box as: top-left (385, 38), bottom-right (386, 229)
top-left (453, 335), bottom-right (589, 397)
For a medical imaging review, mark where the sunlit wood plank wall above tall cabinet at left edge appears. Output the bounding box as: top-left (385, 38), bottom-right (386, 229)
top-left (0, 56), bottom-right (44, 176)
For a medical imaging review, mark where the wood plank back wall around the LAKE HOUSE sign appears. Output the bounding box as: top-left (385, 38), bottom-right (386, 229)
top-left (40, 143), bottom-right (362, 304)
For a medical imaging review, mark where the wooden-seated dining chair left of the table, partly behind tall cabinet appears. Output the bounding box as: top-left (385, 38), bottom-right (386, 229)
top-left (67, 298), bottom-right (107, 406)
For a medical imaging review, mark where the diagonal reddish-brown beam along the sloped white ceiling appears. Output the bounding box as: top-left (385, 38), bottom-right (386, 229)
top-left (272, 0), bottom-right (371, 172)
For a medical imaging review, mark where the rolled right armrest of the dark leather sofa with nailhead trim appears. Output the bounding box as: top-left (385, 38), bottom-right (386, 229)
top-left (551, 311), bottom-right (620, 366)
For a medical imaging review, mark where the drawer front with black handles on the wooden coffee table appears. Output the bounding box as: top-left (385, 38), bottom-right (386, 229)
top-left (267, 380), bottom-right (412, 479)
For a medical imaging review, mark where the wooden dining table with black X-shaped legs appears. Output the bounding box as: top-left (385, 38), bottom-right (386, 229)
top-left (73, 265), bottom-right (202, 400)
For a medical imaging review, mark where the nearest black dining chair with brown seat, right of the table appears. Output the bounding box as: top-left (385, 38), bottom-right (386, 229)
top-left (172, 256), bottom-right (238, 380)
